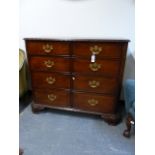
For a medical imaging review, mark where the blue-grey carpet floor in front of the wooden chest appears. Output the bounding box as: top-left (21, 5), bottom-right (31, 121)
top-left (19, 103), bottom-right (135, 155)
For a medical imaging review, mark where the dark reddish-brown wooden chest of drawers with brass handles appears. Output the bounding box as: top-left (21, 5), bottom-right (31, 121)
top-left (25, 38), bottom-right (128, 123)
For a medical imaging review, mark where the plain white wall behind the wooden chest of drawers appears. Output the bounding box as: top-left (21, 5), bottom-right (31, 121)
top-left (19, 0), bottom-right (135, 80)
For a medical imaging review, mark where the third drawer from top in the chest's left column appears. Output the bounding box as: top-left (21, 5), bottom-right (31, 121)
top-left (32, 72), bottom-right (70, 89)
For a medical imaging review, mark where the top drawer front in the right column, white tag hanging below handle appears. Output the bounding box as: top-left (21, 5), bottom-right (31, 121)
top-left (73, 43), bottom-right (122, 58)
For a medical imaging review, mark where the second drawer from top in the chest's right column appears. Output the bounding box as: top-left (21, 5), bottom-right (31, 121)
top-left (73, 59), bottom-right (120, 77)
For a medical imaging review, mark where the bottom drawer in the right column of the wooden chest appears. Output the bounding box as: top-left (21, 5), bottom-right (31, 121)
top-left (74, 93), bottom-right (116, 113)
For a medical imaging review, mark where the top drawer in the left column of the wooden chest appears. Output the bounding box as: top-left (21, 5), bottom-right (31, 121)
top-left (26, 40), bottom-right (69, 55)
